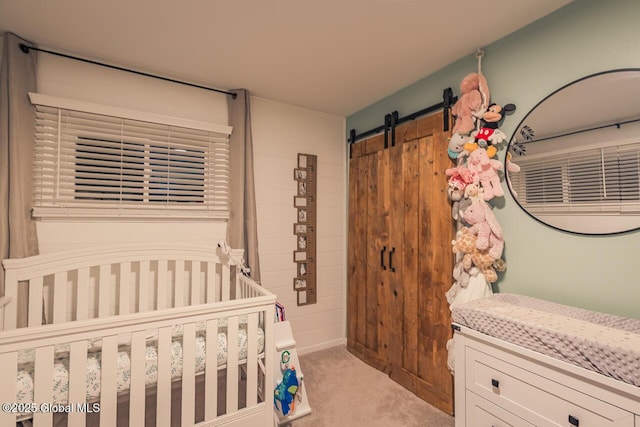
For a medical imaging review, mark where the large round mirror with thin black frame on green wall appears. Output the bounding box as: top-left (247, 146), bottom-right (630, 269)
top-left (505, 69), bottom-right (640, 234)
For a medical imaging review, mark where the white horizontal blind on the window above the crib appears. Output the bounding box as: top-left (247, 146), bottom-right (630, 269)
top-left (32, 97), bottom-right (229, 218)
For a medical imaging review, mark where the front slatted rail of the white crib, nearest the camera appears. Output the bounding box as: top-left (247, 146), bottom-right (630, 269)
top-left (0, 294), bottom-right (275, 426)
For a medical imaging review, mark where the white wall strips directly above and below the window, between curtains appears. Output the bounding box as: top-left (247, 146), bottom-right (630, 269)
top-left (37, 53), bottom-right (228, 253)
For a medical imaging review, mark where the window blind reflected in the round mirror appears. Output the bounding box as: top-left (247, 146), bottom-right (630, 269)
top-left (510, 142), bottom-right (640, 214)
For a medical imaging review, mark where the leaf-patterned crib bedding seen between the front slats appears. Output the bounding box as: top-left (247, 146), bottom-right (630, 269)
top-left (16, 316), bottom-right (264, 415)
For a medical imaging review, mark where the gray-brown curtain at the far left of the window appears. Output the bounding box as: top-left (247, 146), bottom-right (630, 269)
top-left (0, 33), bottom-right (38, 326)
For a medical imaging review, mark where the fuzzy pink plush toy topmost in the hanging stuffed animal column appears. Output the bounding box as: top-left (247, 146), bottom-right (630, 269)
top-left (451, 73), bottom-right (490, 134)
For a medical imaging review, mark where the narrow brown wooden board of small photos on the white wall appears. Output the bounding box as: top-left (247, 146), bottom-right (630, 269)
top-left (293, 154), bottom-right (318, 305)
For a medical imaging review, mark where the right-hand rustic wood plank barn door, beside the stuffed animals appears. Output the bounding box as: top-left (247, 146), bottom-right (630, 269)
top-left (390, 114), bottom-right (453, 413)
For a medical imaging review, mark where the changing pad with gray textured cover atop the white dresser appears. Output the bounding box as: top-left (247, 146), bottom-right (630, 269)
top-left (451, 294), bottom-right (640, 386)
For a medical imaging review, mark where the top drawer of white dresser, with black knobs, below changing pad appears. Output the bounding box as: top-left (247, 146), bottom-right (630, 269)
top-left (465, 347), bottom-right (634, 427)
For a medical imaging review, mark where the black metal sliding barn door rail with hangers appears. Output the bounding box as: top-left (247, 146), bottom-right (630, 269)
top-left (347, 87), bottom-right (458, 157)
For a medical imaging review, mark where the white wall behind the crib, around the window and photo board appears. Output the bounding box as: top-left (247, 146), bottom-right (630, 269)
top-left (31, 54), bottom-right (346, 352)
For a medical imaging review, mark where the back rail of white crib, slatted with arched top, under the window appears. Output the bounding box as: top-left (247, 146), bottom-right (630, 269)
top-left (0, 243), bottom-right (251, 330)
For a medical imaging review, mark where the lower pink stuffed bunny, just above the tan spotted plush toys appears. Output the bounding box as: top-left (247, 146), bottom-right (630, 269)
top-left (462, 201), bottom-right (504, 259)
